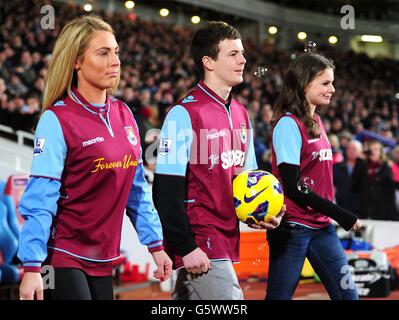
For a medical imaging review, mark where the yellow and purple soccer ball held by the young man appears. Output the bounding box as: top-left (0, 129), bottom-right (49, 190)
top-left (233, 170), bottom-right (284, 224)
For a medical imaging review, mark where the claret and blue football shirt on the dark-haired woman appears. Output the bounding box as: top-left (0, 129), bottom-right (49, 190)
top-left (272, 112), bottom-right (334, 228)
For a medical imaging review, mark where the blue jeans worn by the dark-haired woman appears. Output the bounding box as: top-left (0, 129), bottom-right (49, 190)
top-left (266, 222), bottom-right (359, 300)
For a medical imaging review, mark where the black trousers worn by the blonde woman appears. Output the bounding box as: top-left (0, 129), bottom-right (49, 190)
top-left (44, 268), bottom-right (113, 300)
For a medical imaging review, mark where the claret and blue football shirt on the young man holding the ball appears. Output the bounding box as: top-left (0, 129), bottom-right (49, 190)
top-left (155, 81), bottom-right (257, 268)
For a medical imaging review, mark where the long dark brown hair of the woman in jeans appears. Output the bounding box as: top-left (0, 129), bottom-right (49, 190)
top-left (273, 53), bottom-right (335, 138)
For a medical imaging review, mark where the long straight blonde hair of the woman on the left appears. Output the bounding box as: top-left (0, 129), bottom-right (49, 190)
top-left (42, 15), bottom-right (119, 113)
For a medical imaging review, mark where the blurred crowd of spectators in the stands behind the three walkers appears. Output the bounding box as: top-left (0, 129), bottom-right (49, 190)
top-left (0, 0), bottom-right (399, 220)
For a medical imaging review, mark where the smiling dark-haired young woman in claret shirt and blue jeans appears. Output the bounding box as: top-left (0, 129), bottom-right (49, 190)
top-left (266, 53), bottom-right (360, 300)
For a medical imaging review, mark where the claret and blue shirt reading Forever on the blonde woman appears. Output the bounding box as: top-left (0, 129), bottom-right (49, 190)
top-left (18, 89), bottom-right (163, 275)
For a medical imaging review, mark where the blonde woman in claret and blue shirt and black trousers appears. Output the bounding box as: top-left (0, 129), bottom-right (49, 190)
top-left (18, 16), bottom-right (171, 300)
